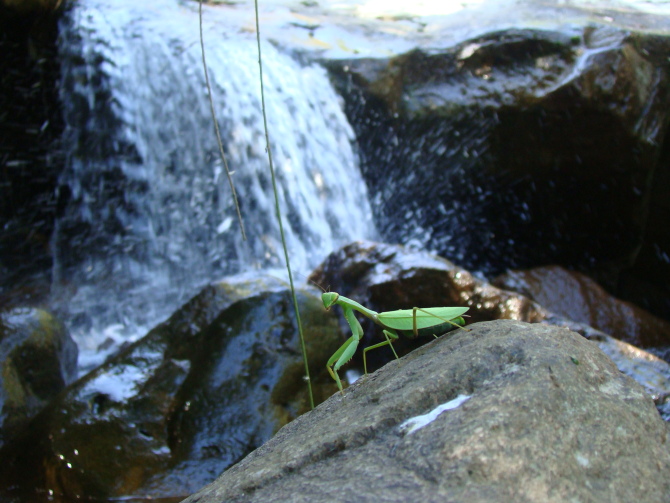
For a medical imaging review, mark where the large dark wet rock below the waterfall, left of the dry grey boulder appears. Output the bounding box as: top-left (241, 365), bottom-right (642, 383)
top-left (0, 277), bottom-right (341, 501)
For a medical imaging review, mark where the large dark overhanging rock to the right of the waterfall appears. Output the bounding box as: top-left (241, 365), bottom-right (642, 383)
top-left (327, 26), bottom-right (670, 316)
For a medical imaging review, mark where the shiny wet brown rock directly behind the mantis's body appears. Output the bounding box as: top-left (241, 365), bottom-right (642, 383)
top-left (310, 241), bottom-right (670, 405)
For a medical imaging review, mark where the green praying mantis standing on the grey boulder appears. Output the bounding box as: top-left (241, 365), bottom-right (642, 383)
top-left (321, 292), bottom-right (468, 392)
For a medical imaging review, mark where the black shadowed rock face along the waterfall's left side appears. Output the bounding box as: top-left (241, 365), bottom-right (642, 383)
top-left (0, 0), bottom-right (65, 307)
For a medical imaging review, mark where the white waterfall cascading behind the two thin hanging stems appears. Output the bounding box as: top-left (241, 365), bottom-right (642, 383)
top-left (53, 0), bottom-right (372, 367)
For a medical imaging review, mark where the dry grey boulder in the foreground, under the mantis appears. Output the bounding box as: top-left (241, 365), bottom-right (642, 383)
top-left (185, 321), bottom-right (670, 503)
